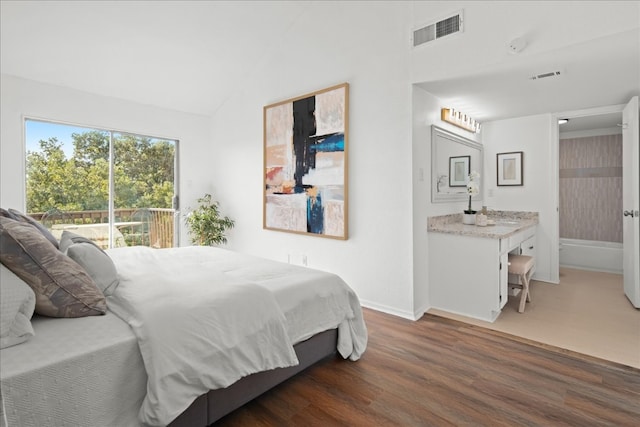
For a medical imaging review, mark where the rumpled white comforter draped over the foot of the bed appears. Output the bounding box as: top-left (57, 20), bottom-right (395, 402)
top-left (107, 246), bottom-right (367, 425)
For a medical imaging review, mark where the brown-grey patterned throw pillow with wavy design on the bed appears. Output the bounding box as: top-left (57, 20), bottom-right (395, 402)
top-left (0, 216), bottom-right (107, 317)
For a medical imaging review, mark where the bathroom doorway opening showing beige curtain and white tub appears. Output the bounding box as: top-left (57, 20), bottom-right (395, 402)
top-left (558, 112), bottom-right (623, 274)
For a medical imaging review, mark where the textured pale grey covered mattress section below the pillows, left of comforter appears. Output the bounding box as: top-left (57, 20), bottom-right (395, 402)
top-left (0, 312), bottom-right (147, 427)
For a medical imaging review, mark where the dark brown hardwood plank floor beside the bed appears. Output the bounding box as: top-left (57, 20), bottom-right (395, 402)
top-left (216, 309), bottom-right (640, 426)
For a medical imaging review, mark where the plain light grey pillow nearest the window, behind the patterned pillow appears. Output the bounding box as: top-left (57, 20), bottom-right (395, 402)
top-left (60, 231), bottom-right (120, 297)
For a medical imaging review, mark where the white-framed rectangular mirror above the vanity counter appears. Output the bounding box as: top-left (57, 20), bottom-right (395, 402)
top-left (431, 125), bottom-right (484, 203)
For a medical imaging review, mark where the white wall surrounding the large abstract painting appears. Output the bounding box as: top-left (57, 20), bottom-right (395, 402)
top-left (205, 2), bottom-right (413, 318)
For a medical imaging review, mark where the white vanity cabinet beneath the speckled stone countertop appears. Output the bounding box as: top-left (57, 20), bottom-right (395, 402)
top-left (429, 221), bottom-right (537, 322)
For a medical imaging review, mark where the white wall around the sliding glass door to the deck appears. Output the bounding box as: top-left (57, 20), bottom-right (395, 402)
top-left (0, 75), bottom-right (212, 244)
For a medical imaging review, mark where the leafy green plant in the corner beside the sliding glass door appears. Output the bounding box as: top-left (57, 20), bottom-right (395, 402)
top-left (185, 194), bottom-right (235, 246)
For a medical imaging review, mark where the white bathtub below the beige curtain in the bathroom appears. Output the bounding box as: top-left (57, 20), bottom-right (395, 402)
top-left (560, 238), bottom-right (623, 274)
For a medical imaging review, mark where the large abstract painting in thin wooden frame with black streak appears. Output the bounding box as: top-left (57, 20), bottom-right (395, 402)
top-left (263, 83), bottom-right (349, 240)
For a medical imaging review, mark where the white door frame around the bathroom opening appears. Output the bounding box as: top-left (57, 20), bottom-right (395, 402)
top-left (550, 104), bottom-right (627, 283)
